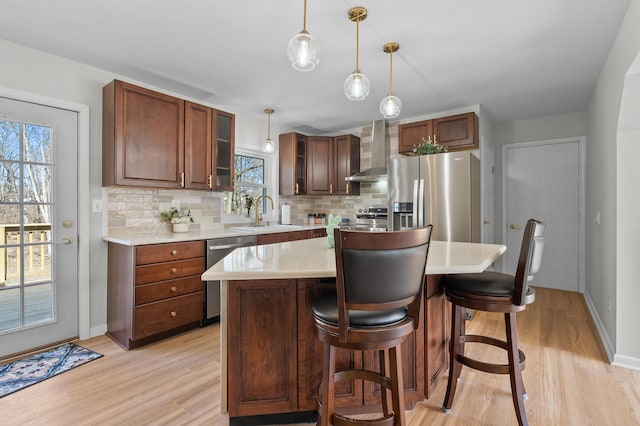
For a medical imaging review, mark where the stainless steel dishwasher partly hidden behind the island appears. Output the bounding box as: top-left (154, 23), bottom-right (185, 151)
top-left (200, 235), bottom-right (257, 326)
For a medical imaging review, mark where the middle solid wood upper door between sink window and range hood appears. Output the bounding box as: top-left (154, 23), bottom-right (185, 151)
top-left (307, 136), bottom-right (335, 195)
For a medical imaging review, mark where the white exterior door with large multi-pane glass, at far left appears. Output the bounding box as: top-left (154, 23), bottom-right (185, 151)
top-left (0, 97), bottom-right (78, 356)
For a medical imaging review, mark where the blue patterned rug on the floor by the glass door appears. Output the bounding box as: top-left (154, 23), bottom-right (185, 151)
top-left (0, 343), bottom-right (102, 398)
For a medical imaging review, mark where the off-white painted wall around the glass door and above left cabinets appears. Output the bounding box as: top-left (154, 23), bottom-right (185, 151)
top-left (0, 39), bottom-right (270, 335)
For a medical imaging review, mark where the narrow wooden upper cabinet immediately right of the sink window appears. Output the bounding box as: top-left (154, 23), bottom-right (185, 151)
top-left (279, 133), bottom-right (307, 195)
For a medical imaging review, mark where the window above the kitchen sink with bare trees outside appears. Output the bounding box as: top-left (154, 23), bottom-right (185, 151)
top-left (224, 154), bottom-right (268, 216)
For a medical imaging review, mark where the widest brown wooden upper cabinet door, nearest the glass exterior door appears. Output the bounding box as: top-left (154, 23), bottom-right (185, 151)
top-left (103, 80), bottom-right (184, 188)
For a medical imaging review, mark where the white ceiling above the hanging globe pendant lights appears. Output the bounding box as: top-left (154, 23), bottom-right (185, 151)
top-left (0, 0), bottom-right (629, 133)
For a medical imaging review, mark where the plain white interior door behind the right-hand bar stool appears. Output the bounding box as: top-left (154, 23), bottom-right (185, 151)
top-left (503, 138), bottom-right (583, 291)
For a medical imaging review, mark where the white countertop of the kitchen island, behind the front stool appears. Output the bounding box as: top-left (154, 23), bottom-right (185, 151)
top-left (202, 238), bottom-right (507, 281)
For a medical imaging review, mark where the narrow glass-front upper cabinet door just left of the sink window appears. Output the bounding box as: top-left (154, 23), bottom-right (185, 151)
top-left (212, 110), bottom-right (235, 191)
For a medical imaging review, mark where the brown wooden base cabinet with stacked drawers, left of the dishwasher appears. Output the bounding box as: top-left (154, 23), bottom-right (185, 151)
top-left (107, 241), bottom-right (205, 349)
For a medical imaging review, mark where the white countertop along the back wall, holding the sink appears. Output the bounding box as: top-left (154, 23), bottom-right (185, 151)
top-left (102, 225), bottom-right (325, 246)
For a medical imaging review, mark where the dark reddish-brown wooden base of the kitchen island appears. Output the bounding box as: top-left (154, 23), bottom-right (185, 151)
top-left (227, 276), bottom-right (447, 417)
